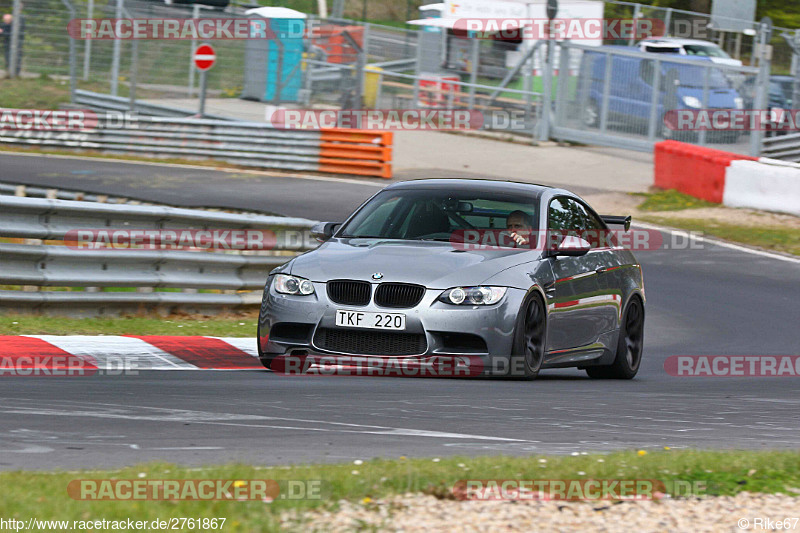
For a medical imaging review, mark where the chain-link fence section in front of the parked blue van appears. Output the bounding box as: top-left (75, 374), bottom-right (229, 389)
top-left (552, 43), bottom-right (766, 154)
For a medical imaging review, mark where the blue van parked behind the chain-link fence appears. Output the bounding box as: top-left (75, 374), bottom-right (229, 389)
top-left (577, 46), bottom-right (744, 138)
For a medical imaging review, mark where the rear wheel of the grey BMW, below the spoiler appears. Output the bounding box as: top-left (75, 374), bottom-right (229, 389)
top-left (586, 296), bottom-right (644, 379)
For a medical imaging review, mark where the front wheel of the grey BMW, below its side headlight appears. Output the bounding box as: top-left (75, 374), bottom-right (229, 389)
top-left (507, 293), bottom-right (547, 380)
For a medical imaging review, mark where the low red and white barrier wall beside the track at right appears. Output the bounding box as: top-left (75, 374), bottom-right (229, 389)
top-left (654, 141), bottom-right (800, 216)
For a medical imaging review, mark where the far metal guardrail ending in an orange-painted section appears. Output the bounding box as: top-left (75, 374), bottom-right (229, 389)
top-left (0, 102), bottom-right (393, 178)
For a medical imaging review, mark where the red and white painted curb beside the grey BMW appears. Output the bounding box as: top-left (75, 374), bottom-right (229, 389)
top-left (0, 335), bottom-right (264, 370)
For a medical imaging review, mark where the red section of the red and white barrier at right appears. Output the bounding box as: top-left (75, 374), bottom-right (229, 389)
top-left (653, 141), bottom-right (758, 204)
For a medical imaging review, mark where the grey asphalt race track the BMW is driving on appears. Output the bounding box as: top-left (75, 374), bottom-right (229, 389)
top-left (0, 152), bottom-right (800, 469)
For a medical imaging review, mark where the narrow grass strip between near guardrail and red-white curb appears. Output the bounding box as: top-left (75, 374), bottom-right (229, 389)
top-left (0, 311), bottom-right (258, 336)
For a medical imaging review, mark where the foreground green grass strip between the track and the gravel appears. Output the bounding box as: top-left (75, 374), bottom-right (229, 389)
top-left (0, 450), bottom-right (800, 531)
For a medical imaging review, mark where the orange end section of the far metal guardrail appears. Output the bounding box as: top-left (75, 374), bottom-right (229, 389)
top-left (319, 128), bottom-right (394, 179)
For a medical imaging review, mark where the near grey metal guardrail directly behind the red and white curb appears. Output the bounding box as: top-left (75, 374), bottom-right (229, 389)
top-left (0, 196), bottom-right (316, 314)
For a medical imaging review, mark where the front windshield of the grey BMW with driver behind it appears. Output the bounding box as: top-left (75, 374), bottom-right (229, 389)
top-left (338, 189), bottom-right (538, 242)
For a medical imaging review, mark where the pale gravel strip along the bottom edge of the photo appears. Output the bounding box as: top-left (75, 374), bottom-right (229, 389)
top-left (281, 492), bottom-right (800, 533)
